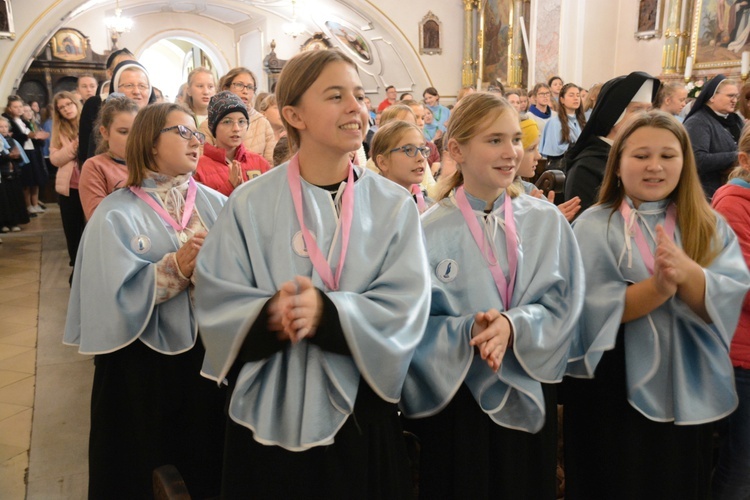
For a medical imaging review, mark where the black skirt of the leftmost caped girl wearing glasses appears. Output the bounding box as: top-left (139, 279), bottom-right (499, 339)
top-left (89, 340), bottom-right (226, 499)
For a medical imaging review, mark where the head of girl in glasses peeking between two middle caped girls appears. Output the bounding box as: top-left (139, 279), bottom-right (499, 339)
top-left (370, 122), bottom-right (432, 213)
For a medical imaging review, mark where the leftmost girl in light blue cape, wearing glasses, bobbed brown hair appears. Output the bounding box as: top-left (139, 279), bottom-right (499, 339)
top-left (64, 104), bottom-right (226, 498)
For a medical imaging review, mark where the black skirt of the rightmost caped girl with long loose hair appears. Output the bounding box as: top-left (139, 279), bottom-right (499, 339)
top-left (563, 328), bottom-right (713, 500)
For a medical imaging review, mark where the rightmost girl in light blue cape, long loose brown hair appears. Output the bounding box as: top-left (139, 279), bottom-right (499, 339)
top-left (564, 111), bottom-right (750, 499)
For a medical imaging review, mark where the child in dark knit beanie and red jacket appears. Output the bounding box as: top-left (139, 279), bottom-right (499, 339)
top-left (195, 90), bottom-right (271, 196)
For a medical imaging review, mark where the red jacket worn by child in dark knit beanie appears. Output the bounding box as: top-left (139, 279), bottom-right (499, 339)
top-left (193, 143), bottom-right (271, 196)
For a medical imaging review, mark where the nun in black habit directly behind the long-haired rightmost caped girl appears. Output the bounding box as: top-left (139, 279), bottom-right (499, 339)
top-left (565, 71), bottom-right (659, 214)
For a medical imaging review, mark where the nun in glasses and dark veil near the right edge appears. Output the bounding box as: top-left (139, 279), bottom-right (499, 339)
top-left (685, 75), bottom-right (743, 200)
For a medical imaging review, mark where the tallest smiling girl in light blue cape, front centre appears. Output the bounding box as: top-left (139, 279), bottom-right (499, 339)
top-left (196, 50), bottom-right (429, 498)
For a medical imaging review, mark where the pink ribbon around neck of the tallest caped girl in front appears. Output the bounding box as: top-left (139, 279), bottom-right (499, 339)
top-left (287, 155), bottom-right (354, 291)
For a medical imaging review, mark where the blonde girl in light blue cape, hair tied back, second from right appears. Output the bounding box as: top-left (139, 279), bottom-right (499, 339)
top-left (402, 93), bottom-right (583, 498)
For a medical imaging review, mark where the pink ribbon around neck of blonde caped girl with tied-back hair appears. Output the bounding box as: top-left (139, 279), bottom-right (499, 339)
top-left (455, 186), bottom-right (518, 311)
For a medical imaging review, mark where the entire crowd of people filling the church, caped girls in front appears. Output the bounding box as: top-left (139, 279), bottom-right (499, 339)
top-left (0, 49), bottom-right (750, 499)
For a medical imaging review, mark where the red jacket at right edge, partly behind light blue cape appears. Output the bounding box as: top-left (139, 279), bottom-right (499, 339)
top-left (711, 181), bottom-right (750, 369)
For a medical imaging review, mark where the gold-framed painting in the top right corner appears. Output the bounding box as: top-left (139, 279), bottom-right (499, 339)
top-left (690, 0), bottom-right (750, 70)
